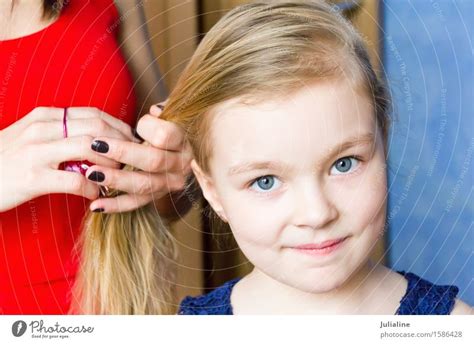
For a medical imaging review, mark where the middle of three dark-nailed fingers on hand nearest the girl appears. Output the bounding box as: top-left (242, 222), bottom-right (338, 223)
top-left (86, 165), bottom-right (186, 198)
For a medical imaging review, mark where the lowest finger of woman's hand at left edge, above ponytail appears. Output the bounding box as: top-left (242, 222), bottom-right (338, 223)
top-left (39, 170), bottom-right (99, 200)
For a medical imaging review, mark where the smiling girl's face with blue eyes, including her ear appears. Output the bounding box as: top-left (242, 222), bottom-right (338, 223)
top-left (192, 80), bottom-right (387, 292)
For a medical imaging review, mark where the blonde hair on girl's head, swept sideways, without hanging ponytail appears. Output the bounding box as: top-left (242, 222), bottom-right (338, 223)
top-left (160, 1), bottom-right (390, 171)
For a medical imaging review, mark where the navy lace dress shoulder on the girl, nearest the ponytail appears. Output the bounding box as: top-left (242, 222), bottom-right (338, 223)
top-left (178, 278), bottom-right (240, 315)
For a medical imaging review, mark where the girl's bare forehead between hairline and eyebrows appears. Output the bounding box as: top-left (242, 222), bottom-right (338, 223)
top-left (210, 78), bottom-right (376, 169)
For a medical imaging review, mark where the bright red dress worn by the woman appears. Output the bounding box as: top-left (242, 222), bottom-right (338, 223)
top-left (0, 0), bottom-right (136, 314)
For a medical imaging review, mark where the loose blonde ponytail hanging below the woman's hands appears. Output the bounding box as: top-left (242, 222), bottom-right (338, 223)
top-left (70, 191), bottom-right (176, 315)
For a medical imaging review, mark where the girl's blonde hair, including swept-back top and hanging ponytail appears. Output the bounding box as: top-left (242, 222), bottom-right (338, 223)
top-left (70, 1), bottom-right (390, 314)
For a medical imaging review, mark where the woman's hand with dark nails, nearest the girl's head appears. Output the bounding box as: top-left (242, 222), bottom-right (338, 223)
top-left (86, 105), bottom-right (192, 213)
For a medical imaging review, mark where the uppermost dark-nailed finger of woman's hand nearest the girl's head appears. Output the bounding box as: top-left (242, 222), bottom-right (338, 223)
top-left (89, 137), bottom-right (191, 174)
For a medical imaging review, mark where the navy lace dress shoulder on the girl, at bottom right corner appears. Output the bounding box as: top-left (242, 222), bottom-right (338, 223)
top-left (397, 271), bottom-right (472, 315)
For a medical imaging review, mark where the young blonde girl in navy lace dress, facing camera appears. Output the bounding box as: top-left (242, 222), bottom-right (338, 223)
top-left (149, 1), bottom-right (471, 314)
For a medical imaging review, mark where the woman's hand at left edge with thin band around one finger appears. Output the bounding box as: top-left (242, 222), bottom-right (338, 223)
top-left (0, 107), bottom-right (138, 212)
